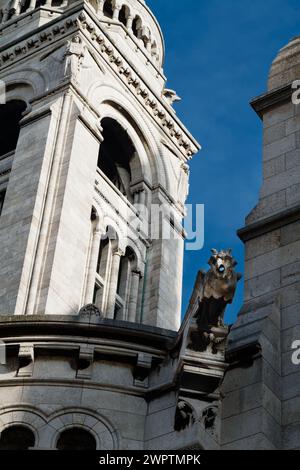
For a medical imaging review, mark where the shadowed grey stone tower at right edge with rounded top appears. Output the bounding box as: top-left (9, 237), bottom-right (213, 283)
top-left (221, 37), bottom-right (300, 449)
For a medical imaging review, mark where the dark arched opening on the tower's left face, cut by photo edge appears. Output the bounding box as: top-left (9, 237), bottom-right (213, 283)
top-left (0, 100), bottom-right (26, 157)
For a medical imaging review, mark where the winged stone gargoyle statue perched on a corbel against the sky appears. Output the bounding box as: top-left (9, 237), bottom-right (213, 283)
top-left (189, 249), bottom-right (242, 351)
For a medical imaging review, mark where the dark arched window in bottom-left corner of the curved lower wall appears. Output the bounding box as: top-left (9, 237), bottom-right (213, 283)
top-left (0, 426), bottom-right (35, 450)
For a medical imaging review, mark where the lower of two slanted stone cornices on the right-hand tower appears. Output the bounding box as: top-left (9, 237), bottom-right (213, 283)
top-left (237, 205), bottom-right (300, 243)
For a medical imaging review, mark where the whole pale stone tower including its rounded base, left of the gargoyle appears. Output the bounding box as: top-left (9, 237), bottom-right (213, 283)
top-left (0, 0), bottom-right (232, 450)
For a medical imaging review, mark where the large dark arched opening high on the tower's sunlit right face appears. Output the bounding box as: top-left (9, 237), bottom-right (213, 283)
top-left (98, 118), bottom-right (136, 202)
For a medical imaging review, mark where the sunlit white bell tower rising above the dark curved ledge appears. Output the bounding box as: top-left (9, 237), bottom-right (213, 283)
top-left (0, 0), bottom-right (199, 330)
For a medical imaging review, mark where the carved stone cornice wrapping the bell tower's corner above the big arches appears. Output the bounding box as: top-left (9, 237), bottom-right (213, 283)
top-left (0, 6), bottom-right (200, 159)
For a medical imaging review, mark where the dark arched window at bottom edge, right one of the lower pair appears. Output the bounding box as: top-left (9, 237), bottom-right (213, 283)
top-left (56, 428), bottom-right (97, 450)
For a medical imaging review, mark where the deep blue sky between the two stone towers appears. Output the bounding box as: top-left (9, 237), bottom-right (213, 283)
top-left (146, 0), bottom-right (300, 322)
